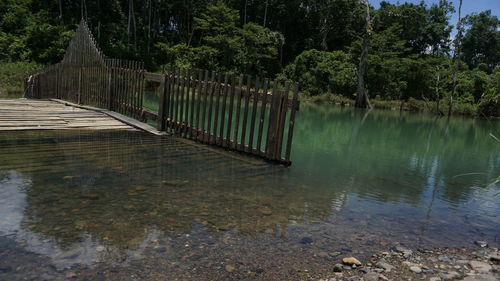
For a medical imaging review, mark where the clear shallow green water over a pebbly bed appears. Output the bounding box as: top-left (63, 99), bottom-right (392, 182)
top-left (0, 105), bottom-right (500, 280)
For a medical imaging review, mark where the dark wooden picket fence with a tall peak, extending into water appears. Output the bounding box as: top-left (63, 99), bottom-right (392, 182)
top-left (19, 20), bottom-right (299, 164)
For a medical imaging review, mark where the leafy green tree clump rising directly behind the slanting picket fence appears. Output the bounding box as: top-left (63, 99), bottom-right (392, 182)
top-left (156, 1), bottom-right (283, 75)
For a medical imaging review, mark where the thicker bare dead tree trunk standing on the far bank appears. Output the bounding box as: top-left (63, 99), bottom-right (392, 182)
top-left (355, 0), bottom-right (372, 108)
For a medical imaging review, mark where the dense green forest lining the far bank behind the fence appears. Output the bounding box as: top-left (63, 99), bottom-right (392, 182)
top-left (0, 0), bottom-right (500, 117)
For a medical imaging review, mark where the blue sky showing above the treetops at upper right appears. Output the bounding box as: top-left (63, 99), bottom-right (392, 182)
top-left (369, 0), bottom-right (500, 37)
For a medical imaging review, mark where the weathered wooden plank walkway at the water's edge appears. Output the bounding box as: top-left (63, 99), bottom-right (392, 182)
top-left (0, 99), bottom-right (135, 131)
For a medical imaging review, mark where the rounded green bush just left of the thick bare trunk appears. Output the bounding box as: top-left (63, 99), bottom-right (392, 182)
top-left (283, 50), bottom-right (356, 97)
